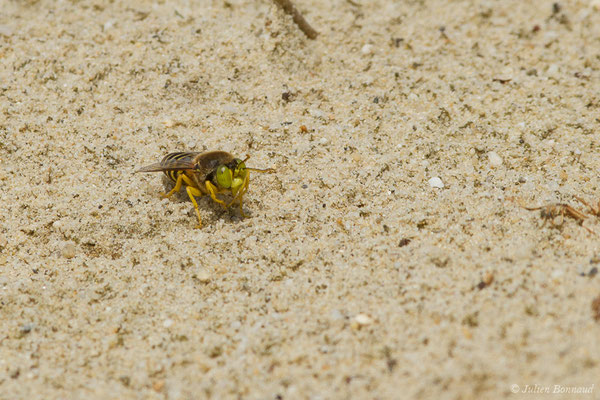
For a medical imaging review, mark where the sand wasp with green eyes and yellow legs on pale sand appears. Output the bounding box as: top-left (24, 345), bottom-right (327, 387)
top-left (136, 151), bottom-right (275, 227)
